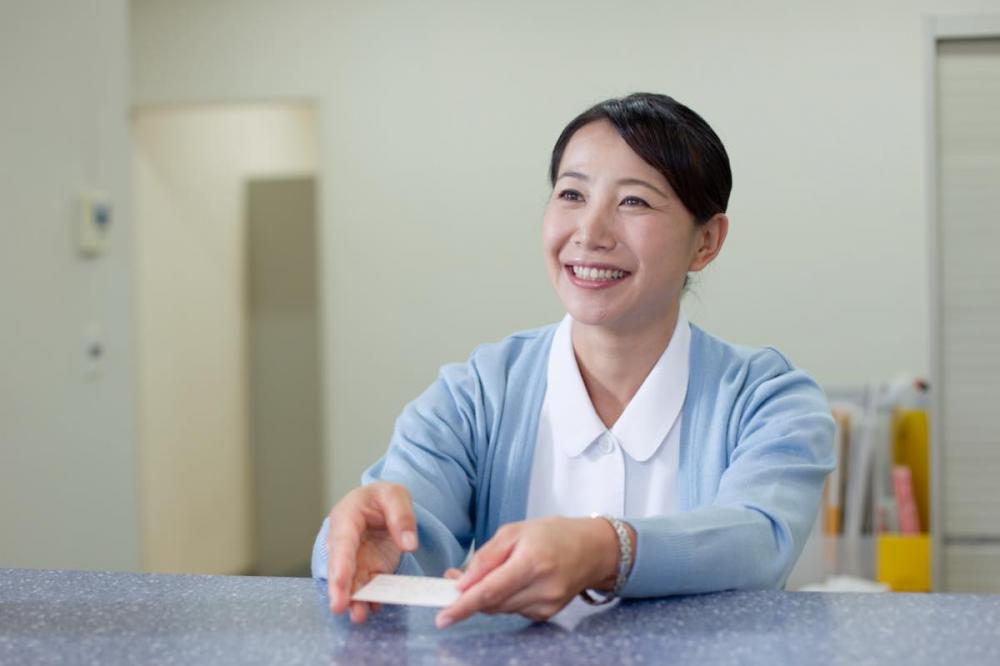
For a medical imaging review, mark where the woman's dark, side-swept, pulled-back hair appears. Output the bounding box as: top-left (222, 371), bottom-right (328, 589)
top-left (549, 93), bottom-right (733, 224)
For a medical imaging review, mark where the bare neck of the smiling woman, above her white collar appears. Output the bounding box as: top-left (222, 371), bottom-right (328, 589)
top-left (571, 306), bottom-right (679, 428)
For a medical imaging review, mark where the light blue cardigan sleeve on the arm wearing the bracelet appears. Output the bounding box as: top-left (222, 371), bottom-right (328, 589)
top-left (622, 350), bottom-right (835, 597)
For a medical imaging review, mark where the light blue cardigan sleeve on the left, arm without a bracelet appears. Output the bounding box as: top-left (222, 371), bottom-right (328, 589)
top-left (312, 361), bottom-right (484, 579)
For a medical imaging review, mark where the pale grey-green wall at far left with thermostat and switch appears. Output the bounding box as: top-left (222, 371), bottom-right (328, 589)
top-left (0, 0), bottom-right (139, 569)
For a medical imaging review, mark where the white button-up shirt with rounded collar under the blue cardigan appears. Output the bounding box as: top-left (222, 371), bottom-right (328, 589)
top-left (527, 313), bottom-right (691, 518)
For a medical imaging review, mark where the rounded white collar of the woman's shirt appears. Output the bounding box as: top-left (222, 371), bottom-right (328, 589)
top-left (546, 313), bottom-right (691, 462)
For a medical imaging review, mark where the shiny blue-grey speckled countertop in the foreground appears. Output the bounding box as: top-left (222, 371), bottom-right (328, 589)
top-left (0, 569), bottom-right (1000, 666)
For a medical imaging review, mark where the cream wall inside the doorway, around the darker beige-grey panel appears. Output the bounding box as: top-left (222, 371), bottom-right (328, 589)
top-left (133, 105), bottom-right (317, 573)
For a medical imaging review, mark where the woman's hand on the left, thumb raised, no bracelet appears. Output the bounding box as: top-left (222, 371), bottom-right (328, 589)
top-left (326, 481), bottom-right (417, 622)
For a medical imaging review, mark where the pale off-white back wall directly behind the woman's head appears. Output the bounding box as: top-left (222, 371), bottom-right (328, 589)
top-left (133, 0), bottom-right (1000, 506)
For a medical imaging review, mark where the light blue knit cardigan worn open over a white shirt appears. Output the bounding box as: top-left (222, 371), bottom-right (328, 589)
top-left (312, 324), bottom-right (834, 597)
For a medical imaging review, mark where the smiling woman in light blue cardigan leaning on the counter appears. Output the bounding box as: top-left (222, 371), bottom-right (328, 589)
top-left (313, 93), bottom-right (834, 627)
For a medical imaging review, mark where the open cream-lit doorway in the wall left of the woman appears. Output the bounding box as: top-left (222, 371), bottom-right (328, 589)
top-left (132, 104), bottom-right (324, 575)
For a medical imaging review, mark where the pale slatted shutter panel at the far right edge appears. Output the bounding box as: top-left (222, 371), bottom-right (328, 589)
top-left (937, 39), bottom-right (1000, 591)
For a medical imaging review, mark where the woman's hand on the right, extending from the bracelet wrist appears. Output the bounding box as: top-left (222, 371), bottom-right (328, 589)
top-left (437, 517), bottom-right (618, 629)
